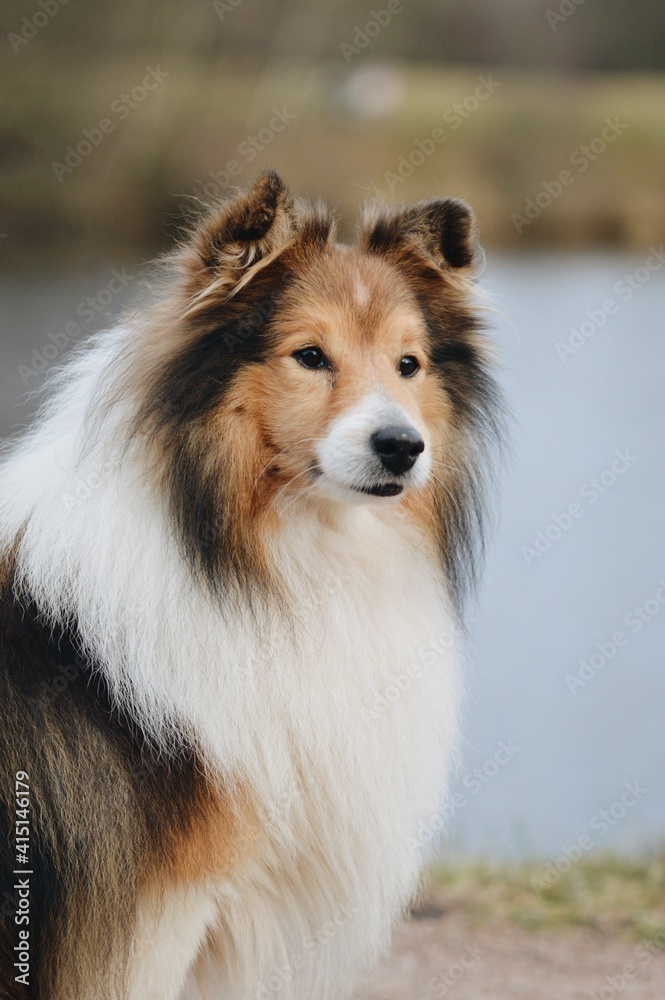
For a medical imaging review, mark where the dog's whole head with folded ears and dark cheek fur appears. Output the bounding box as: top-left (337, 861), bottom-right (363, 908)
top-left (140, 173), bottom-right (500, 596)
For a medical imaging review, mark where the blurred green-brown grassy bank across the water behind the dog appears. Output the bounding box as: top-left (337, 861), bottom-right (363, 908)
top-left (0, 54), bottom-right (665, 263)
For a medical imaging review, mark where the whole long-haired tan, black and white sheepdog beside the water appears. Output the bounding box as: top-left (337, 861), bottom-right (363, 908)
top-left (0, 171), bottom-right (500, 1000)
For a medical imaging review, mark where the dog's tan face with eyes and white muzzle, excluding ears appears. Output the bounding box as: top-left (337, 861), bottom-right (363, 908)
top-left (223, 246), bottom-right (445, 505)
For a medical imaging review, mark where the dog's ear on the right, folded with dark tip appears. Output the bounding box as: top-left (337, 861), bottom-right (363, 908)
top-left (360, 198), bottom-right (481, 272)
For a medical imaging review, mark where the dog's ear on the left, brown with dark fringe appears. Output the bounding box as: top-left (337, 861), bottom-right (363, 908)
top-left (190, 170), bottom-right (296, 285)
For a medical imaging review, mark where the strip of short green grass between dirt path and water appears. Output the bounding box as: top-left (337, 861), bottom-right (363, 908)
top-left (430, 856), bottom-right (665, 947)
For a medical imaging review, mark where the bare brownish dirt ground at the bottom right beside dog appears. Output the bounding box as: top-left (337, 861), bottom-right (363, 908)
top-left (354, 897), bottom-right (665, 1000)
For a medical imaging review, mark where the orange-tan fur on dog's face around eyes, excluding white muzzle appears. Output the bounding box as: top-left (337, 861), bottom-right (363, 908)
top-left (195, 242), bottom-right (452, 560)
